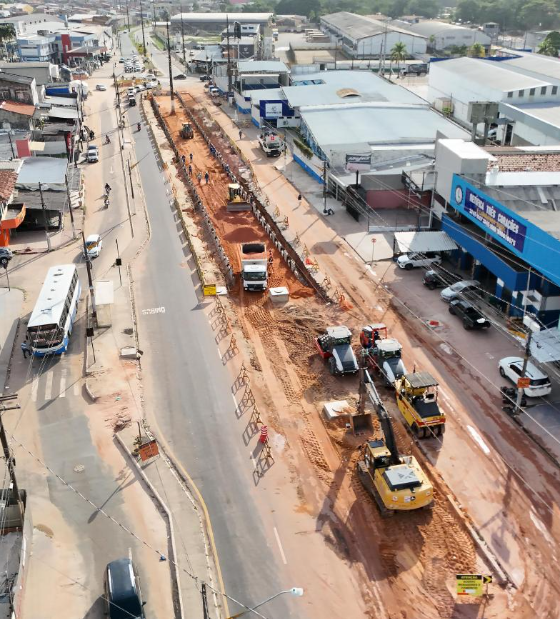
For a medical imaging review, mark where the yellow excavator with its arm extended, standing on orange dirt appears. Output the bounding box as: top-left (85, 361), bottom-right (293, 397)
top-left (357, 368), bottom-right (434, 517)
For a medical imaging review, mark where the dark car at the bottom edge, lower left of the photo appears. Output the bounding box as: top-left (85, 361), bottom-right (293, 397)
top-left (104, 558), bottom-right (146, 619)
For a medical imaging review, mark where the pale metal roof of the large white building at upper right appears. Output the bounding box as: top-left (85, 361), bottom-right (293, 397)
top-left (430, 58), bottom-right (551, 92)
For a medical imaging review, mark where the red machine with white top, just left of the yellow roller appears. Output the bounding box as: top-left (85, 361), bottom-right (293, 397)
top-left (360, 323), bottom-right (406, 387)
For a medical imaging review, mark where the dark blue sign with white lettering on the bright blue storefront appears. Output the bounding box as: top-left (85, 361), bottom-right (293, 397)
top-left (455, 185), bottom-right (527, 252)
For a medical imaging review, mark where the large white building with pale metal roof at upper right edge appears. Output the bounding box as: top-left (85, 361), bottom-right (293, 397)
top-left (428, 58), bottom-right (560, 126)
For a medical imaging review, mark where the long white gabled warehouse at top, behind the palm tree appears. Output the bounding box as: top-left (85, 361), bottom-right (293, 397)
top-left (321, 11), bottom-right (428, 58)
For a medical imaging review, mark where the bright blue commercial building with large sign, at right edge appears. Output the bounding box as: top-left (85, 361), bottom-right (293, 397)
top-left (435, 140), bottom-right (560, 327)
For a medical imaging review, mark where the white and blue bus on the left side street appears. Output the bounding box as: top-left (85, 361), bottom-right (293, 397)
top-left (27, 265), bottom-right (82, 357)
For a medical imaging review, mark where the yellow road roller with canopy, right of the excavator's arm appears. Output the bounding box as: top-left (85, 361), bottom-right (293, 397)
top-left (395, 372), bottom-right (445, 438)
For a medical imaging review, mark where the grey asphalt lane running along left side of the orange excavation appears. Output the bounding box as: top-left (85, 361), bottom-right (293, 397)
top-left (123, 37), bottom-right (293, 618)
